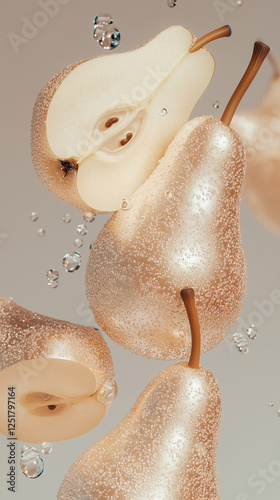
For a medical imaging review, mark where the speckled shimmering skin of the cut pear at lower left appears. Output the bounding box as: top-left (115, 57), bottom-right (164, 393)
top-left (0, 297), bottom-right (114, 389)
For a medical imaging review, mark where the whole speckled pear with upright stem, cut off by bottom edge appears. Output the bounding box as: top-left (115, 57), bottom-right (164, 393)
top-left (57, 290), bottom-right (221, 500)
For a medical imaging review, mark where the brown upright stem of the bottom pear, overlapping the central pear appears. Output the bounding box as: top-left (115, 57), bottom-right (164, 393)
top-left (181, 288), bottom-right (201, 368)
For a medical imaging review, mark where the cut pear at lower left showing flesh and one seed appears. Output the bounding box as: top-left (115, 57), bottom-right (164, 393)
top-left (0, 297), bottom-right (116, 443)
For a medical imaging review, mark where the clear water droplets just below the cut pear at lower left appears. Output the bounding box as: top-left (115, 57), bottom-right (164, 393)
top-left (20, 442), bottom-right (52, 479)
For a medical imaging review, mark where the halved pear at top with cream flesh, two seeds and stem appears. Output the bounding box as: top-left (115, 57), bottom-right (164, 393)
top-left (32, 26), bottom-right (231, 212)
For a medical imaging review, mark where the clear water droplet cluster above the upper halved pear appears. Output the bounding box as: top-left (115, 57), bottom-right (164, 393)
top-left (93, 14), bottom-right (121, 50)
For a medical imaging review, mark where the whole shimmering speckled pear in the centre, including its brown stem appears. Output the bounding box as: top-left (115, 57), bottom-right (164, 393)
top-left (86, 43), bottom-right (269, 359)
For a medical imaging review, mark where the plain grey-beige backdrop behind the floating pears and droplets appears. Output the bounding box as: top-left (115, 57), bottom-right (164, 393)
top-left (0, 0), bottom-right (280, 500)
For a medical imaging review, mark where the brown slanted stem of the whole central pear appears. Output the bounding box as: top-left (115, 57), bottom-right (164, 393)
top-left (221, 42), bottom-right (270, 126)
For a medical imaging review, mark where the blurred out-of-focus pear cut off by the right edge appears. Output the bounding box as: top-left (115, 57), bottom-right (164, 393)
top-left (233, 51), bottom-right (280, 235)
